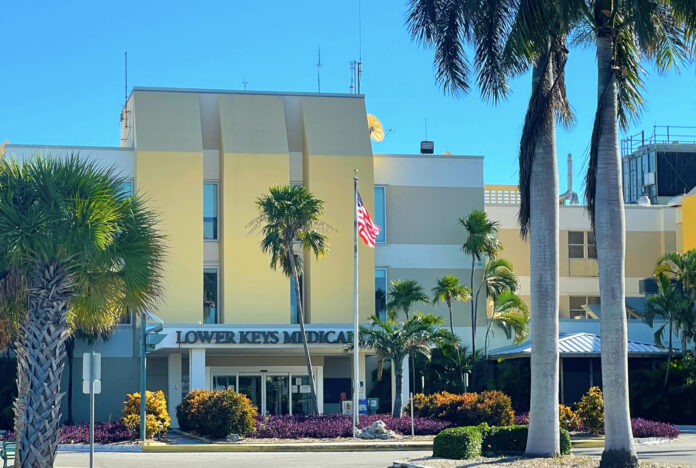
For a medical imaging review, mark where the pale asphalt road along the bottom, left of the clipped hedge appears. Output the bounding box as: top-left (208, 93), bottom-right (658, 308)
top-left (55, 451), bottom-right (430, 468)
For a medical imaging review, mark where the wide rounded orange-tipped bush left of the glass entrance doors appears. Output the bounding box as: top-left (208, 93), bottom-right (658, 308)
top-left (176, 389), bottom-right (258, 439)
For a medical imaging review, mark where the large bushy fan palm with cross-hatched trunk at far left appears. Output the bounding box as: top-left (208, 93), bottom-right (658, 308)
top-left (0, 156), bottom-right (164, 467)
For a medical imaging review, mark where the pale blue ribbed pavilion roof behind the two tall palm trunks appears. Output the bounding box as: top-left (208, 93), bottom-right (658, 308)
top-left (490, 333), bottom-right (681, 359)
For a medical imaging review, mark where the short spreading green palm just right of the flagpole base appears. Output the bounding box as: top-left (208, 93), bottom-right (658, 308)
top-left (354, 312), bottom-right (458, 418)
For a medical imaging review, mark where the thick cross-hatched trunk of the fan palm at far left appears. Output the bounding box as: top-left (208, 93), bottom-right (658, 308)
top-left (15, 261), bottom-right (72, 468)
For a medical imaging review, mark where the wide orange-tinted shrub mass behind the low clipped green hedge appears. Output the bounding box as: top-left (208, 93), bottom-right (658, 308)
top-left (413, 390), bottom-right (515, 426)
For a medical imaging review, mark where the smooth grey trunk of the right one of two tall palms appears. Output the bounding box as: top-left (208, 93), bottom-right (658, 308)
top-left (594, 33), bottom-right (638, 467)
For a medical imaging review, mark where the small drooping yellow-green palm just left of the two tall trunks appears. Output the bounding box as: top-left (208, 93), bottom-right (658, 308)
top-left (484, 289), bottom-right (529, 358)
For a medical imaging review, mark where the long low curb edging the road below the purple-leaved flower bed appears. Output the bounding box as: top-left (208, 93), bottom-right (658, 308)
top-left (142, 442), bottom-right (433, 453)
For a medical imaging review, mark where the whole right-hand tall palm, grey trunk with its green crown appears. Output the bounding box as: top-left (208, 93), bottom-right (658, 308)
top-left (585, 5), bottom-right (696, 467)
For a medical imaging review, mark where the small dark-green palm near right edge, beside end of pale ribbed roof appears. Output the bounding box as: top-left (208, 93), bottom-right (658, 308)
top-left (643, 272), bottom-right (692, 388)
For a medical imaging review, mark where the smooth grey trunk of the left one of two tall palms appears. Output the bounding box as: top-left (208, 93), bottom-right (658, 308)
top-left (525, 51), bottom-right (560, 456)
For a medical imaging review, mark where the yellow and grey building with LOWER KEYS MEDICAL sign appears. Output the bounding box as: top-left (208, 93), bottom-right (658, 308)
top-left (4, 88), bottom-right (485, 420)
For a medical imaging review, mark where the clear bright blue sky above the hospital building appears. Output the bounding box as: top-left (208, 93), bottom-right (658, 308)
top-left (0, 0), bottom-right (696, 191)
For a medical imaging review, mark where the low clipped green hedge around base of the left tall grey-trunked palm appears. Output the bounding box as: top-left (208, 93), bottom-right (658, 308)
top-left (433, 424), bottom-right (571, 459)
